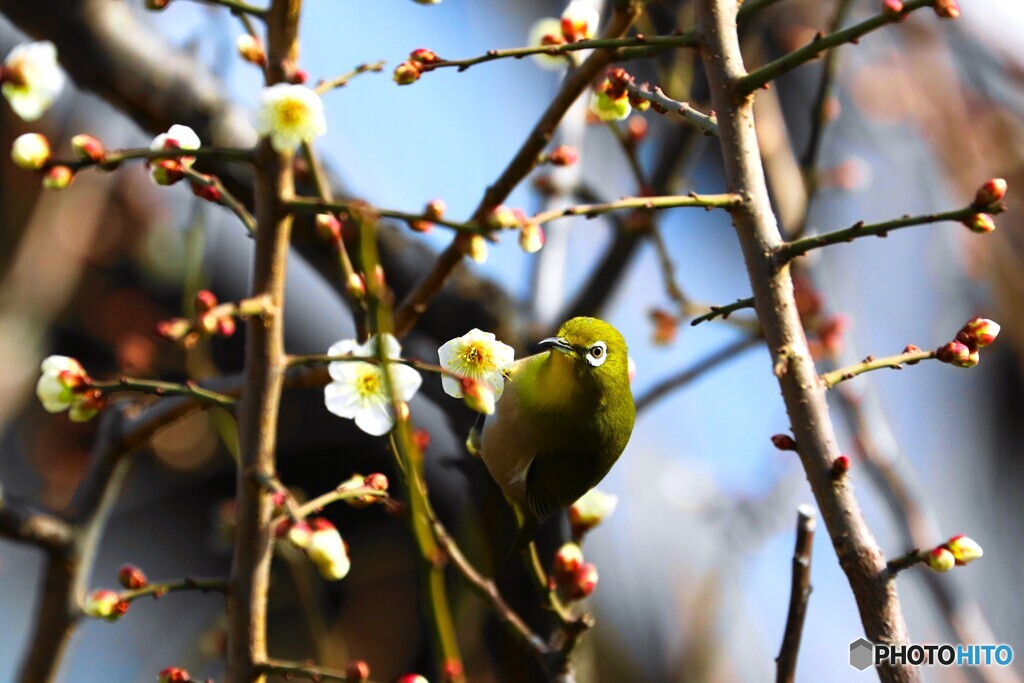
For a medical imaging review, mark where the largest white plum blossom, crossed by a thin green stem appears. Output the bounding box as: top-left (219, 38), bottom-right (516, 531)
top-left (324, 333), bottom-right (423, 436)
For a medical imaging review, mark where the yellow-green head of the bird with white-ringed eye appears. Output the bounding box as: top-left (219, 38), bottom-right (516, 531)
top-left (541, 317), bottom-right (629, 387)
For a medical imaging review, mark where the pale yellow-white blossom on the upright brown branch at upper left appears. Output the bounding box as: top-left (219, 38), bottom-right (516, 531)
top-left (256, 83), bottom-right (327, 152)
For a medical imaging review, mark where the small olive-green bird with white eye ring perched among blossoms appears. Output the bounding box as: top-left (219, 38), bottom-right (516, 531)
top-left (480, 317), bottom-right (636, 552)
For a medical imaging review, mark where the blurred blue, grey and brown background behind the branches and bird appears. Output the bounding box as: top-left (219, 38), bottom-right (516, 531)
top-left (0, 0), bottom-right (1024, 682)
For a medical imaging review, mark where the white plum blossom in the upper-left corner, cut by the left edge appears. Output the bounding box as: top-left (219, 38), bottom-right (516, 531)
top-left (2, 40), bottom-right (66, 121)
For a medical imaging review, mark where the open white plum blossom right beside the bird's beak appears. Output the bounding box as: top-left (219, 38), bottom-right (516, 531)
top-left (437, 328), bottom-right (515, 403)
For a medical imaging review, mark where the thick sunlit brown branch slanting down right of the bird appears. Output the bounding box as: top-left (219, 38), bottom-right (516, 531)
top-left (697, 0), bottom-right (919, 682)
